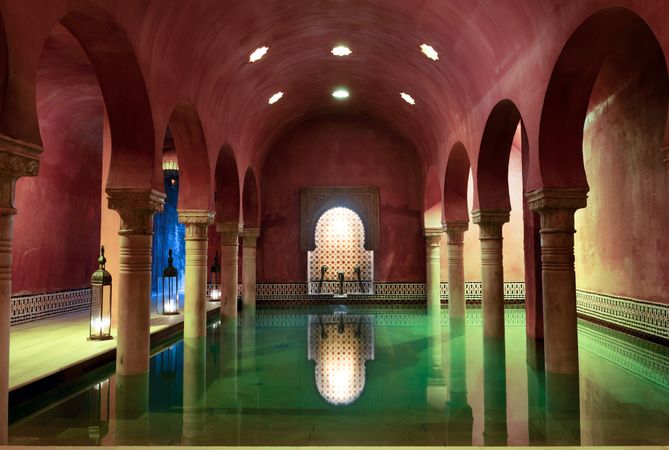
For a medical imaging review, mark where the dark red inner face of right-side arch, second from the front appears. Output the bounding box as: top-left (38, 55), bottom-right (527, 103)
top-left (474, 100), bottom-right (527, 211)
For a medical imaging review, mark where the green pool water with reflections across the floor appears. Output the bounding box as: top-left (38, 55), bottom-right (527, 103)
top-left (10, 308), bottom-right (669, 445)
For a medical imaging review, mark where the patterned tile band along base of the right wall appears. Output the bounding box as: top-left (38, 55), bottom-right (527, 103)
top-left (576, 289), bottom-right (669, 344)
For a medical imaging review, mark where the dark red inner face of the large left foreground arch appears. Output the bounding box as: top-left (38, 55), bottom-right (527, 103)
top-left (51, 7), bottom-right (157, 191)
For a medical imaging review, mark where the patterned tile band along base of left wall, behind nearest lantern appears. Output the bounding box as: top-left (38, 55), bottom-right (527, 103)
top-left (10, 288), bottom-right (91, 325)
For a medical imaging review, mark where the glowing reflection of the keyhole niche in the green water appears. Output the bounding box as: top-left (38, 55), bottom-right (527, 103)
top-left (308, 312), bottom-right (374, 405)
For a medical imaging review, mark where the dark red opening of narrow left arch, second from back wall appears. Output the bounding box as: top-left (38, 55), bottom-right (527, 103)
top-left (215, 145), bottom-right (240, 223)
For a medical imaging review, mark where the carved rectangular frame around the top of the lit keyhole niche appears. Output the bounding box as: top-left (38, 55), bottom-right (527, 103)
top-left (300, 187), bottom-right (379, 251)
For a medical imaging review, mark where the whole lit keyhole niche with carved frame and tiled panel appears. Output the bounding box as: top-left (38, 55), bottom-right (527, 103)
top-left (300, 186), bottom-right (379, 294)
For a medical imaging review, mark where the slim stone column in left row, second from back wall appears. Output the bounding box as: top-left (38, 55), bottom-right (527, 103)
top-left (216, 222), bottom-right (242, 318)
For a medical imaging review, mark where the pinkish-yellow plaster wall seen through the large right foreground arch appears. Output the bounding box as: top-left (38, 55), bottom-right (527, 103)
top-left (575, 33), bottom-right (669, 304)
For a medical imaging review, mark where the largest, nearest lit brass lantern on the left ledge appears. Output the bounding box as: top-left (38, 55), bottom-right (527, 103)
top-left (88, 245), bottom-right (112, 341)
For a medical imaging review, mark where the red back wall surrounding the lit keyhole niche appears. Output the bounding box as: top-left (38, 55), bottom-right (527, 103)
top-left (258, 115), bottom-right (425, 282)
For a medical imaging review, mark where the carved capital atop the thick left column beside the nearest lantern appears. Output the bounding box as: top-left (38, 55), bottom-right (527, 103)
top-left (107, 188), bottom-right (166, 235)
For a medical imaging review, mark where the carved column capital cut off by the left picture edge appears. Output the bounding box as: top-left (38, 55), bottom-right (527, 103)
top-left (0, 134), bottom-right (43, 216)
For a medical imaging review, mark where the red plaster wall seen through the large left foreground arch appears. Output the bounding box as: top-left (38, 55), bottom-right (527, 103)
top-left (12, 27), bottom-right (103, 294)
